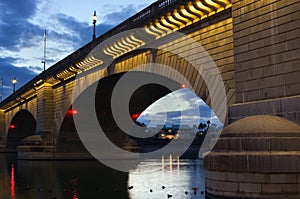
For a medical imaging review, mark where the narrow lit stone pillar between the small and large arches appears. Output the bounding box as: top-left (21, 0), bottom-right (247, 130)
top-left (36, 84), bottom-right (55, 142)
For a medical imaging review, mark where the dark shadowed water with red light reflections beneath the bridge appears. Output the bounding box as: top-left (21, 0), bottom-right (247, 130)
top-left (0, 154), bottom-right (129, 199)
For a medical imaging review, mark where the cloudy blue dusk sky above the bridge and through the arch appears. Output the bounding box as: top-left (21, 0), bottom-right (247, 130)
top-left (0, 0), bottom-right (220, 125)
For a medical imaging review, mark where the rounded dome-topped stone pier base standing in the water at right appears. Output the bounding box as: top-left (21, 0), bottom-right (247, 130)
top-left (204, 115), bottom-right (300, 199)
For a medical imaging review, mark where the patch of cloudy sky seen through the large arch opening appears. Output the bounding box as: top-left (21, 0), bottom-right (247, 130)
top-left (138, 89), bottom-right (222, 126)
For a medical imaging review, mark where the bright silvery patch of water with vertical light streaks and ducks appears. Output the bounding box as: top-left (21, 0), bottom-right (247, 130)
top-left (128, 156), bottom-right (205, 199)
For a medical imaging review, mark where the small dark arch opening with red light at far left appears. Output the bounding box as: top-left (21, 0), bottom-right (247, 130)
top-left (6, 109), bottom-right (36, 151)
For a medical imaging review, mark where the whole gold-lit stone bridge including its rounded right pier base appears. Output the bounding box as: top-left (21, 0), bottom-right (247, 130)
top-left (0, 0), bottom-right (300, 198)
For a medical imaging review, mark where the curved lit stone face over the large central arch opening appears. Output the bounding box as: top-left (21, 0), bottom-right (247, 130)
top-left (56, 25), bottom-right (230, 152)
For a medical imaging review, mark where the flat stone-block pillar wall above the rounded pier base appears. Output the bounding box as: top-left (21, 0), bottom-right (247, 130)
top-left (229, 0), bottom-right (300, 124)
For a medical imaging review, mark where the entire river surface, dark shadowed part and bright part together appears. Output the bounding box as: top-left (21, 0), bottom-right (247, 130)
top-left (0, 154), bottom-right (205, 199)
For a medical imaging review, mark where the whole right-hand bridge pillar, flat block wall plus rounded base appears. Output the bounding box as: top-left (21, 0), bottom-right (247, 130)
top-left (204, 0), bottom-right (300, 199)
